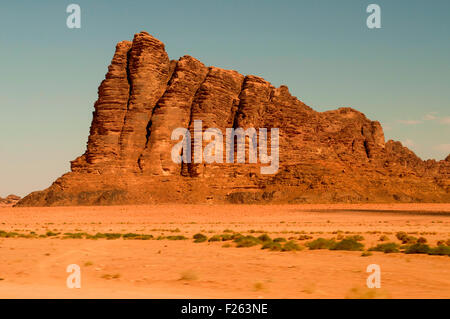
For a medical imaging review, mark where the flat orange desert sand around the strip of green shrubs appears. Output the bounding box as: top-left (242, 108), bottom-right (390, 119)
top-left (0, 204), bottom-right (450, 298)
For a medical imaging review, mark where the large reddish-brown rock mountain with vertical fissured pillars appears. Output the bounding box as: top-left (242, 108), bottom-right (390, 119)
top-left (18, 32), bottom-right (450, 206)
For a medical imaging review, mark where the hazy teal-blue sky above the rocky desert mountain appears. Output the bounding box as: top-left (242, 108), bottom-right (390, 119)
top-left (0, 0), bottom-right (450, 197)
